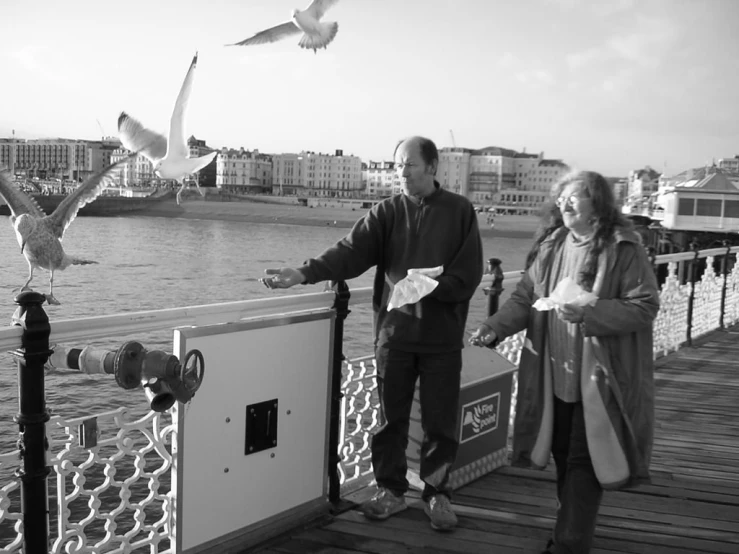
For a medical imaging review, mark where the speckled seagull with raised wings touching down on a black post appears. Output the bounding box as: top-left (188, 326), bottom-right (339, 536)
top-left (0, 158), bottom-right (130, 305)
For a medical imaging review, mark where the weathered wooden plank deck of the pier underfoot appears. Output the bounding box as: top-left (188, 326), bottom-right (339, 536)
top-left (258, 327), bottom-right (739, 554)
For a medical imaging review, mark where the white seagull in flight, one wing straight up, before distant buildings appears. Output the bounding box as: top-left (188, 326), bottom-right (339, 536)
top-left (118, 52), bottom-right (218, 204)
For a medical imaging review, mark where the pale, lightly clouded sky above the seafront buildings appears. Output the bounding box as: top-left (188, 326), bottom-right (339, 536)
top-left (0, 0), bottom-right (739, 176)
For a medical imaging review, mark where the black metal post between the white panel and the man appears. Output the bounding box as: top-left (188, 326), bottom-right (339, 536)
top-left (328, 281), bottom-right (351, 503)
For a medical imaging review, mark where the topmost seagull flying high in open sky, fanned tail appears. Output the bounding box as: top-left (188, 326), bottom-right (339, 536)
top-left (226, 0), bottom-right (339, 53)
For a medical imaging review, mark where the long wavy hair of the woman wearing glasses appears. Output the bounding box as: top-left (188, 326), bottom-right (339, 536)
top-left (526, 171), bottom-right (633, 291)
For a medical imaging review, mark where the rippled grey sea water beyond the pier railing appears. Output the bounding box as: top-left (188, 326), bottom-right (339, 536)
top-left (0, 212), bottom-right (531, 453)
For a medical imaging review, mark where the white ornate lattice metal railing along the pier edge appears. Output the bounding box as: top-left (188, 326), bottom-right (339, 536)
top-left (0, 247), bottom-right (739, 553)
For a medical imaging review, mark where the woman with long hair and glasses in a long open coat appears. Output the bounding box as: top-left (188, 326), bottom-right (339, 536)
top-left (470, 171), bottom-right (659, 553)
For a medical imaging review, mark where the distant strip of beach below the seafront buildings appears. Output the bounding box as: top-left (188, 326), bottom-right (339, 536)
top-left (131, 196), bottom-right (538, 238)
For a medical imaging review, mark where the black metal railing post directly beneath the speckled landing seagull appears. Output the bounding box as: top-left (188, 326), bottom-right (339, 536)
top-left (12, 291), bottom-right (51, 554)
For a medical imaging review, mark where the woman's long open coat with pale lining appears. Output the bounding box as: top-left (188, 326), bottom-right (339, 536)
top-left (485, 228), bottom-right (659, 489)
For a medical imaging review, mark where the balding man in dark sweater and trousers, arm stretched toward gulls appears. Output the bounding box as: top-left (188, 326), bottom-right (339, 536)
top-left (263, 137), bottom-right (483, 531)
